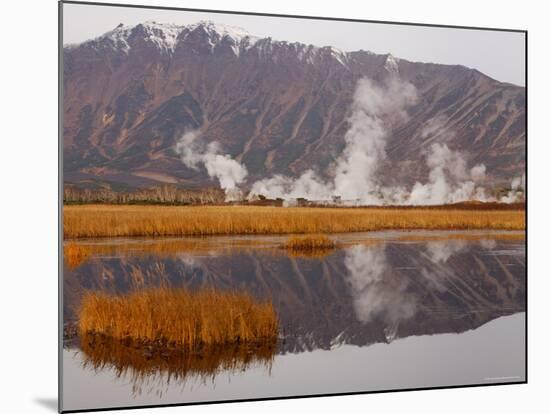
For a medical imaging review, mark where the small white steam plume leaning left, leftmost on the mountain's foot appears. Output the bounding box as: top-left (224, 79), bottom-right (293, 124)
top-left (175, 130), bottom-right (248, 201)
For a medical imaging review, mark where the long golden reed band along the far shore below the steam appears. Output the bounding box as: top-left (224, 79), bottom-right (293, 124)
top-left (63, 205), bottom-right (525, 239)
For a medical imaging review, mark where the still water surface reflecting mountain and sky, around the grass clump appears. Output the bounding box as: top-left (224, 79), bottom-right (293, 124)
top-left (63, 232), bottom-right (525, 410)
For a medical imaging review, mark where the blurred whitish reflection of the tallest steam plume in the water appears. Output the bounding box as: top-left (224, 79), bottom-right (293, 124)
top-left (344, 245), bottom-right (416, 340)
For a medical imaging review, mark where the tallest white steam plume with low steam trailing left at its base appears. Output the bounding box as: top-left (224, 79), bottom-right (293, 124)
top-left (250, 76), bottom-right (416, 204)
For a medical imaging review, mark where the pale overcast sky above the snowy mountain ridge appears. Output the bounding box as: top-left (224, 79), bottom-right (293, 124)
top-left (63, 4), bottom-right (525, 86)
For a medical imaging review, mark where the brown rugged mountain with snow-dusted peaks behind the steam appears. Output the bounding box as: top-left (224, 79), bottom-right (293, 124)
top-left (63, 22), bottom-right (526, 189)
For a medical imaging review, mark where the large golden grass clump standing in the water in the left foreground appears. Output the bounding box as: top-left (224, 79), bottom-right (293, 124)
top-left (79, 288), bottom-right (278, 349)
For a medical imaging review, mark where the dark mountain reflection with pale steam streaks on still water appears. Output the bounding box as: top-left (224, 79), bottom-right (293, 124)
top-left (64, 238), bottom-right (525, 353)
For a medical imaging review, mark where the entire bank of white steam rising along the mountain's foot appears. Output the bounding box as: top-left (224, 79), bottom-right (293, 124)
top-left (176, 73), bottom-right (525, 205)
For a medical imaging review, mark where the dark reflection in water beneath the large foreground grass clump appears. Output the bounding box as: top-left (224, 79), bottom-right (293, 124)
top-left (80, 336), bottom-right (277, 396)
